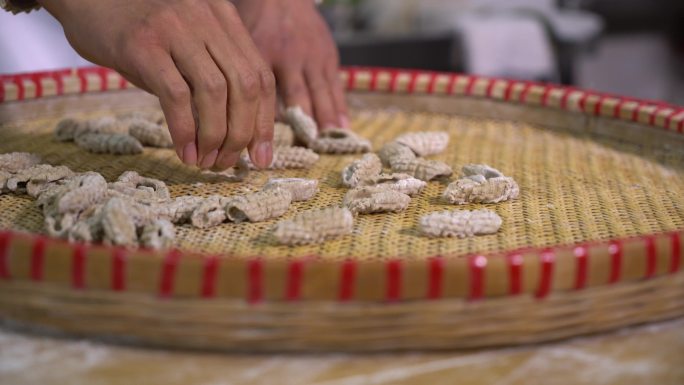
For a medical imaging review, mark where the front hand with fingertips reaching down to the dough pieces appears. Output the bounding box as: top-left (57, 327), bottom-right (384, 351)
top-left (40, 0), bottom-right (276, 169)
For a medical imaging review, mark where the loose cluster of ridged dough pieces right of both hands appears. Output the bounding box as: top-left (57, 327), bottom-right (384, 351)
top-left (342, 131), bottom-right (520, 238)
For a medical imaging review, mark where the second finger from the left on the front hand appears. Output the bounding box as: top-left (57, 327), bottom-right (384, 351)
top-left (171, 40), bottom-right (228, 168)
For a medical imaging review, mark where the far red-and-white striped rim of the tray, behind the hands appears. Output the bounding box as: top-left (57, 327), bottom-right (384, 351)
top-left (0, 67), bottom-right (684, 133)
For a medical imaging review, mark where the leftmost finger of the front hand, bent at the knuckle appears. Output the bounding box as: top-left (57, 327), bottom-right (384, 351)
top-left (134, 48), bottom-right (198, 166)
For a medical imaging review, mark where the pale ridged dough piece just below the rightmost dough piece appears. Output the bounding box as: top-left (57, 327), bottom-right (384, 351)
top-left (419, 209), bottom-right (502, 238)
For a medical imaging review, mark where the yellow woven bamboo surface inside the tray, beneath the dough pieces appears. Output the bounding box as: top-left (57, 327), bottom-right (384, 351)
top-left (0, 100), bottom-right (684, 260)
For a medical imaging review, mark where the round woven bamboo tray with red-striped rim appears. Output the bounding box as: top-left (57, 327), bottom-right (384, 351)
top-left (0, 68), bottom-right (684, 351)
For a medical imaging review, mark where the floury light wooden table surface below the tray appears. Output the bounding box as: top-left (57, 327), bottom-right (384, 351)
top-left (0, 319), bottom-right (684, 385)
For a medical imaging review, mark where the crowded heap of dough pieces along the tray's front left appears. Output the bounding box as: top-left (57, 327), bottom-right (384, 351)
top-left (0, 148), bottom-right (352, 249)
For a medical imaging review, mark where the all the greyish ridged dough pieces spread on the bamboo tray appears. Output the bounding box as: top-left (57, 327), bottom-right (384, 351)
top-left (0, 107), bottom-right (519, 249)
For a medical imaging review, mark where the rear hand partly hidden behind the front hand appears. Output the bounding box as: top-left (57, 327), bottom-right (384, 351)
top-left (234, 0), bottom-right (349, 128)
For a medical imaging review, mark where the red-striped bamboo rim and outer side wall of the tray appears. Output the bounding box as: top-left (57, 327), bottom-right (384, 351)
top-left (0, 67), bottom-right (684, 350)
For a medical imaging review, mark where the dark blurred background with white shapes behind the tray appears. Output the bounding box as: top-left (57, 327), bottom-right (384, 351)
top-left (0, 0), bottom-right (684, 105)
